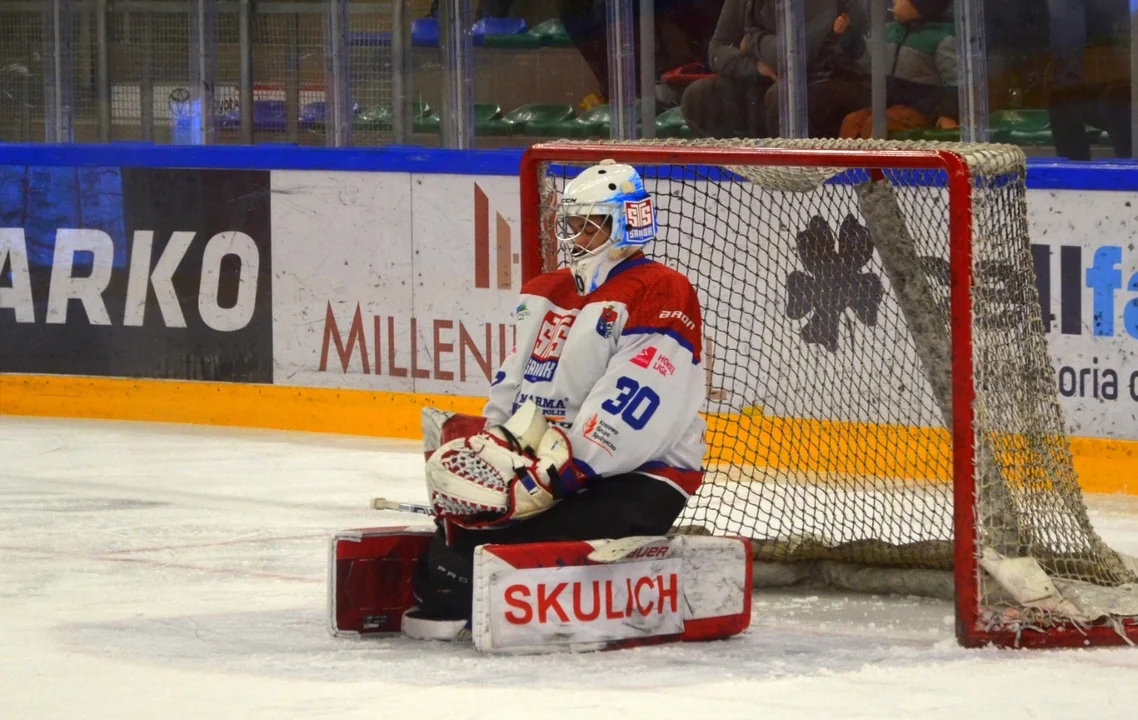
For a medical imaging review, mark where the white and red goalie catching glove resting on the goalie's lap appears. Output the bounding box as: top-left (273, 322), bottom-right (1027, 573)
top-left (427, 400), bottom-right (572, 529)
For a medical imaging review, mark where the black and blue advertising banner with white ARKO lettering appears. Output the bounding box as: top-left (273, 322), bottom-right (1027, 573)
top-left (0, 166), bottom-right (273, 382)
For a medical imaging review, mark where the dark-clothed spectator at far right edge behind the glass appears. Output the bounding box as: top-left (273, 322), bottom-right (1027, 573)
top-left (1047, 0), bottom-right (1138, 160)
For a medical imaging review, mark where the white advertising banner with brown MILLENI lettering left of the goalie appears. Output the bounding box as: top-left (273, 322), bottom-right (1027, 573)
top-left (273, 172), bottom-right (520, 395)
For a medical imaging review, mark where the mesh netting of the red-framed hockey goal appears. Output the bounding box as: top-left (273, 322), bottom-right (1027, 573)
top-left (538, 135), bottom-right (1136, 623)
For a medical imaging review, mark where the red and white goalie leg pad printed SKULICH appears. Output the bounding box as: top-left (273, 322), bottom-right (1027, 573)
top-left (472, 536), bottom-right (751, 653)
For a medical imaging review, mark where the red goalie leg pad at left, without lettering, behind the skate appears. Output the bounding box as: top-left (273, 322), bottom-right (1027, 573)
top-left (328, 527), bottom-right (435, 637)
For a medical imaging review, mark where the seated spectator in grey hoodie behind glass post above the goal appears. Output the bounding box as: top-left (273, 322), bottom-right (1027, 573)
top-left (683, 0), bottom-right (871, 138)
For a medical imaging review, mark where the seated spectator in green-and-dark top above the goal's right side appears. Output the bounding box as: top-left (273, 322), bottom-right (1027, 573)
top-left (841, 0), bottom-right (959, 138)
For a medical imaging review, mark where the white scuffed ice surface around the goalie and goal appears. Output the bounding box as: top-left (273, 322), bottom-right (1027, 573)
top-left (0, 416), bottom-right (1138, 720)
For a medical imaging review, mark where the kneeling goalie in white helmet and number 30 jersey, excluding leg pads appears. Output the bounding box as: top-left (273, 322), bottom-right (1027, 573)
top-left (404, 160), bottom-right (707, 637)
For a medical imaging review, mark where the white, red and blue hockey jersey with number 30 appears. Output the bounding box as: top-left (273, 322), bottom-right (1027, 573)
top-left (483, 254), bottom-right (707, 496)
